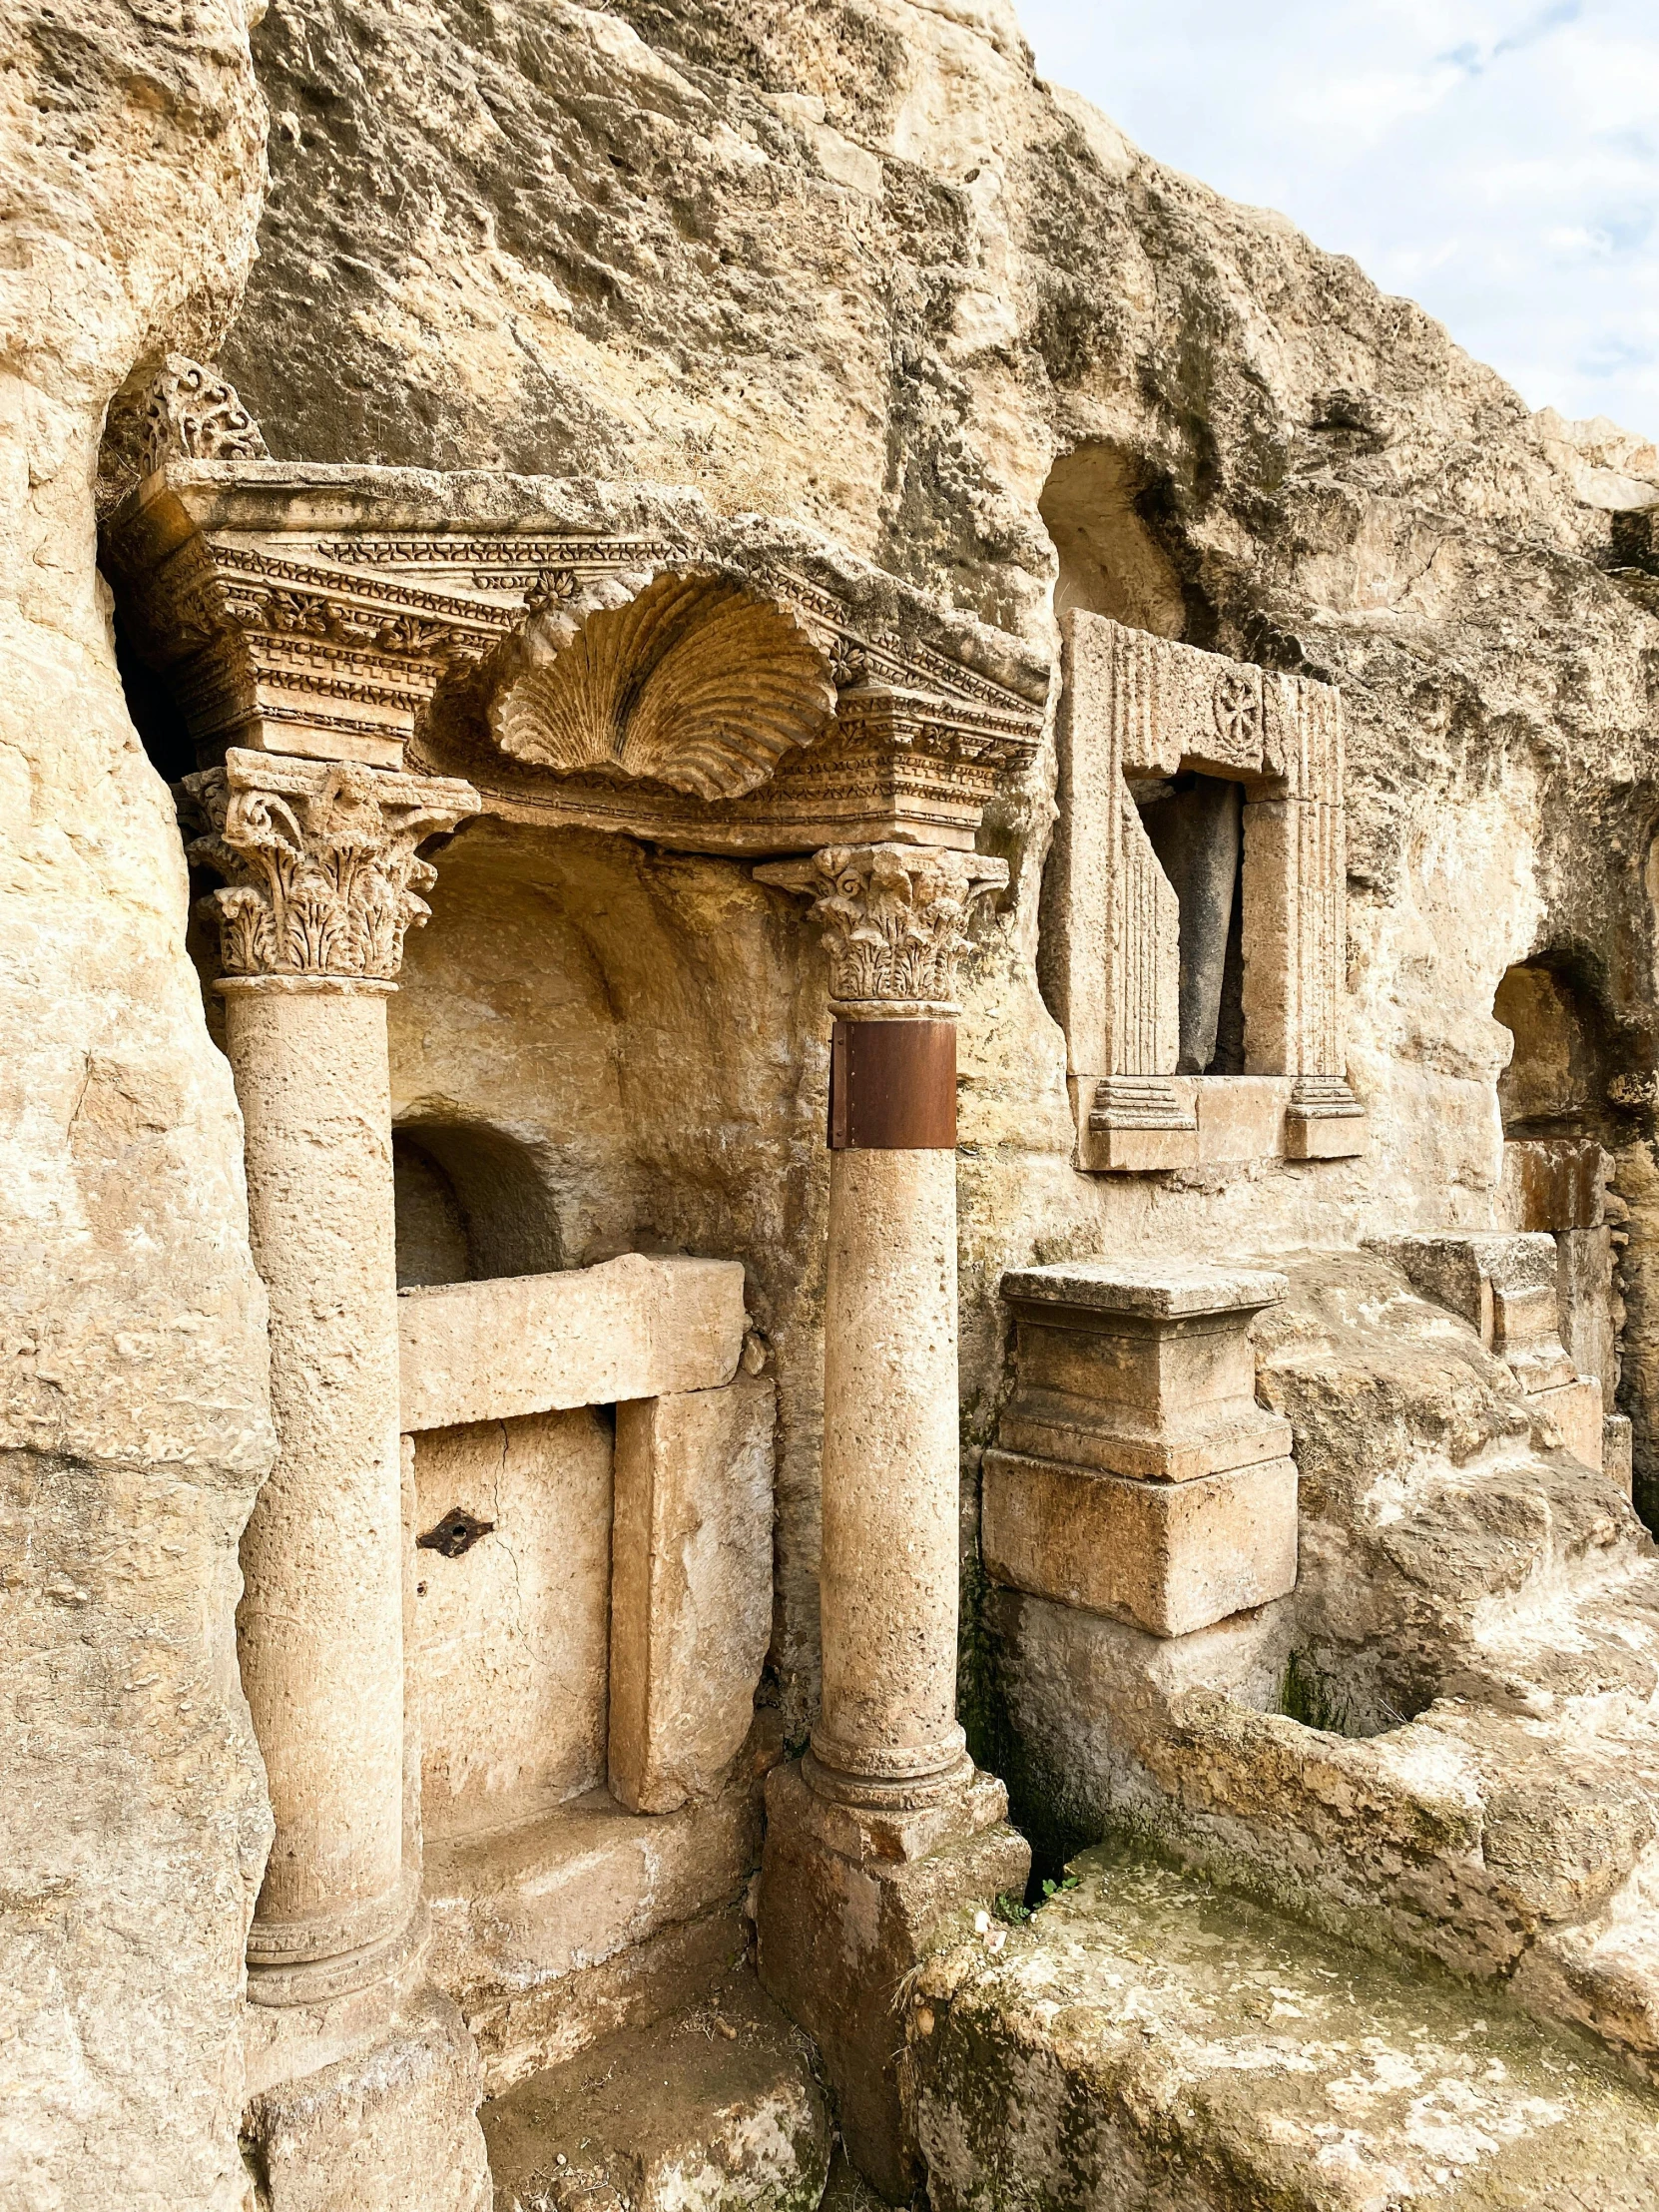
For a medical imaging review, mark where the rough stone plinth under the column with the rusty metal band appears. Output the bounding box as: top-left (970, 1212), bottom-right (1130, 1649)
top-left (759, 1763), bottom-right (1031, 2203)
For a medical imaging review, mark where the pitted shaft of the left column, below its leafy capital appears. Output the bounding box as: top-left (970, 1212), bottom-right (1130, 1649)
top-left (226, 977), bottom-right (411, 1964)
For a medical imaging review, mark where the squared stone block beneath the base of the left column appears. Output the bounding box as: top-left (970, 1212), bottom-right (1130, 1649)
top-left (242, 1951), bottom-right (491, 2212)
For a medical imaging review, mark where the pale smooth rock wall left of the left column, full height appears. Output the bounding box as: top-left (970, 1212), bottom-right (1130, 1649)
top-left (0, 0), bottom-right (270, 2212)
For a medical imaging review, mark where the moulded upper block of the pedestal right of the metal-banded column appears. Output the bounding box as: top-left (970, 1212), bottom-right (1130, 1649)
top-left (997, 1261), bottom-right (1290, 1482)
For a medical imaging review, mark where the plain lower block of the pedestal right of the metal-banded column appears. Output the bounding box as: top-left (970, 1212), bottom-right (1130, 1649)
top-left (982, 1451), bottom-right (1297, 1637)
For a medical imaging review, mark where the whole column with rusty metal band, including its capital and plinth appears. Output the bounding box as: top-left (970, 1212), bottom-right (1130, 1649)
top-left (757, 845), bottom-right (1028, 2199)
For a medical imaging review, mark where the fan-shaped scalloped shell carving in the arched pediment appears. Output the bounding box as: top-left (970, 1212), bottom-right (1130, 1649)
top-left (491, 573), bottom-right (836, 799)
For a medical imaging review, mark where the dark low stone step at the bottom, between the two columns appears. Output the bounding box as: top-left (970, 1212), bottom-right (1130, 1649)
top-left (480, 1968), bottom-right (830, 2212)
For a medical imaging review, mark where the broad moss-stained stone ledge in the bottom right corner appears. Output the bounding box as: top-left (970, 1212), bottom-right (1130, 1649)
top-left (907, 1850), bottom-right (1659, 2212)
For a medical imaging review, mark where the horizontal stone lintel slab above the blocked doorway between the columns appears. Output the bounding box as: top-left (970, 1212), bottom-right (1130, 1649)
top-left (398, 1252), bottom-right (744, 1433)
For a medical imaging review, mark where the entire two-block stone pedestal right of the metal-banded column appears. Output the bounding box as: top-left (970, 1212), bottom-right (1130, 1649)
top-left (982, 1261), bottom-right (1297, 1637)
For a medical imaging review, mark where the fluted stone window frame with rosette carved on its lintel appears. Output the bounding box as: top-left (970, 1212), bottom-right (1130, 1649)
top-left (1044, 613), bottom-right (1363, 1170)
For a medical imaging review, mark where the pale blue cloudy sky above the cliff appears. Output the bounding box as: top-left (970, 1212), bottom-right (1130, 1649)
top-left (1017, 0), bottom-right (1659, 438)
